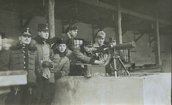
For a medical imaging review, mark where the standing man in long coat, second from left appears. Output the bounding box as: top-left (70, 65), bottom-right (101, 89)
top-left (35, 24), bottom-right (54, 105)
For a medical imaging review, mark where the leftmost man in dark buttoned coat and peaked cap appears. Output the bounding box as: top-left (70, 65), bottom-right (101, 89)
top-left (6, 28), bottom-right (38, 105)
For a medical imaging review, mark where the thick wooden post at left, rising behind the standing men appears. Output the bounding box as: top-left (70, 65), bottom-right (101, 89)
top-left (48, 0), bottom-right (55, 38)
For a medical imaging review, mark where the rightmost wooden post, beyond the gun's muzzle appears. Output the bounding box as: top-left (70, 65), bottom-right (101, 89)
top-left (155, 17), bottom-right (161, 66)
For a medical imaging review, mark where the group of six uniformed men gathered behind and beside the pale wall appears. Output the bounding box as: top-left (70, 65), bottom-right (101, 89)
top-left (0, 24), bottom-right (119, 105)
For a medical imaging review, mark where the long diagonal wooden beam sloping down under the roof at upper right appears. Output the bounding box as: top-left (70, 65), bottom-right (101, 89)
top-left (77, 0), bottom-right (172, 25)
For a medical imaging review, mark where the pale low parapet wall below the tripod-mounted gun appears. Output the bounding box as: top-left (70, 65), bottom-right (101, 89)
top-left (52, 73), bottom-right (171, 105)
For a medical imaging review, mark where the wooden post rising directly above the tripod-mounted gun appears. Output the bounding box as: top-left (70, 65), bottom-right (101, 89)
top-left (117, 0), bottom-right (122, 44)
